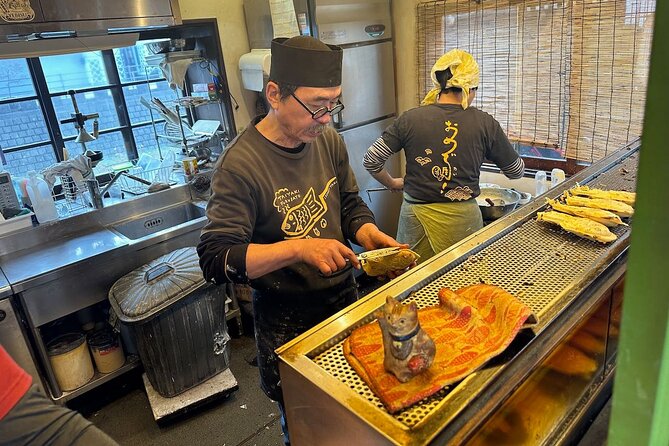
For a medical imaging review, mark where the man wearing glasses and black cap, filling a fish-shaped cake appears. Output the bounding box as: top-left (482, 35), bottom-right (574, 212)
top-left (198, 36), bottom-right (406, 443)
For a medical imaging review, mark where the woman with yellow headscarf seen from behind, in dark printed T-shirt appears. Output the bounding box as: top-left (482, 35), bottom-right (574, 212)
top-left (363, 49), bottom-right (525, 260)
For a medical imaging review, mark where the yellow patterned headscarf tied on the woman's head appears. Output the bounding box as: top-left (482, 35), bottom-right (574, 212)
top-left (420, 49), bottom-right (479, 109)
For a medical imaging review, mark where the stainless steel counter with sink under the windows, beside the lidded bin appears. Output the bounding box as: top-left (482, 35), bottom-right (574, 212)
top-left (0, 181), bottom-right (217, 401)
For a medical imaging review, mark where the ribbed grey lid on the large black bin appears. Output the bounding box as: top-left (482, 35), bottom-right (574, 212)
top-left (109, 247), bottom-right (205, 323)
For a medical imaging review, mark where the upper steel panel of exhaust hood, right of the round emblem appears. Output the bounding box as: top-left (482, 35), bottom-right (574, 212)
top-left (41, 0), bottom-right (173, 22)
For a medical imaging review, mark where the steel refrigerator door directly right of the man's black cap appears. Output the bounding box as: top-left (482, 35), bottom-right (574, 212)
top-left (340, 42), bottom-right (395, 126)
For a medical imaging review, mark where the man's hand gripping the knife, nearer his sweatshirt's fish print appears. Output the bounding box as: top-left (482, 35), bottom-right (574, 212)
top-left (294, 238), bottom-right (360, 276)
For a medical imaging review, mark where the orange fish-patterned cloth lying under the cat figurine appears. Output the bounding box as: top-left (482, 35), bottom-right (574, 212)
top-left (343, 284), bottom-right (531, 413)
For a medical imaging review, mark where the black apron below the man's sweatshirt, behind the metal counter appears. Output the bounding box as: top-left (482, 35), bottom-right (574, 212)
top-left (253, 273), bottom-right (358, 404)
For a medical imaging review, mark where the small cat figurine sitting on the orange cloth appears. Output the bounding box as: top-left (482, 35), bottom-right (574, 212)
top-left (375, 296), bottom-right (436, 383)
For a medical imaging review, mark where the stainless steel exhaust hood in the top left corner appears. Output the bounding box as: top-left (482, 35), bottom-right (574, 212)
top-left (0, 0), bottom-right (181, 42)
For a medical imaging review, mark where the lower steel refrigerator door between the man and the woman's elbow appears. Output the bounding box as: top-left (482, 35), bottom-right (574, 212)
top-left (341, 118), bottom-right (402, 237)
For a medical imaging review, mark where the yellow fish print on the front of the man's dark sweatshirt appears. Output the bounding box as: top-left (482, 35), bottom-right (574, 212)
top-left (274, 177), bottom-right (337, 239)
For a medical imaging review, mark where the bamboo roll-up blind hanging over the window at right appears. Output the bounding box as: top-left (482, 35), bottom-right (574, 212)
top-left (416, 0), bottom-right (655, 163)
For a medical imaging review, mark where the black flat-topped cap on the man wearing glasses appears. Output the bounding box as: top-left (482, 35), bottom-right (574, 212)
top-left (269, 36), bottom-right (343, 87)
